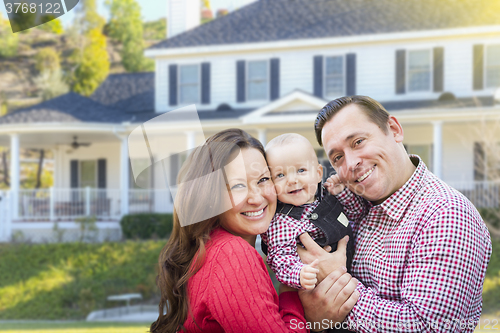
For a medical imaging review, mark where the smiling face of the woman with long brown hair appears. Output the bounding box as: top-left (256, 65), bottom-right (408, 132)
top-left (220, 148), bottom-right (276, 246)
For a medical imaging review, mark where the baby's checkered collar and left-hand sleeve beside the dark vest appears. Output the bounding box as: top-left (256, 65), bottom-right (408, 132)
top-left (261, 199), bottom-right (325, 289)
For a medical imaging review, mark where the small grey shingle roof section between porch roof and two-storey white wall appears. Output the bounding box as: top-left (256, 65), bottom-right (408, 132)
top-left (90, 72), bottom-right (155, 112)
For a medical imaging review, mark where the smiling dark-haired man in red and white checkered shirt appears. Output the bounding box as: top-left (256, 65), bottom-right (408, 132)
top-left (298, 96), bottom-right (491, 332)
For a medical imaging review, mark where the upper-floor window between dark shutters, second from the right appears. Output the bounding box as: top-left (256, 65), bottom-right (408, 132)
top-left (408, 50), bottom-right (432, 92)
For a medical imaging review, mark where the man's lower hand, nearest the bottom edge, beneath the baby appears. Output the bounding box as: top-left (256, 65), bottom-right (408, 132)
top-left (299, 267), bottom-right (359, 327)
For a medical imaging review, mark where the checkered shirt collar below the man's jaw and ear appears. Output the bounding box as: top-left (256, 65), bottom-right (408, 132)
top-left (380, 155), bottom-right (427, 220)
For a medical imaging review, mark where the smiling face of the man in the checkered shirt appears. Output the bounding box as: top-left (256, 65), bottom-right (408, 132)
top-left (321, 104), bottom-right (406, 204)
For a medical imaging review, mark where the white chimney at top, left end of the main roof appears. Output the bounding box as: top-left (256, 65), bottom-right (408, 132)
top-left (167, 0), bottom-right (201, 38)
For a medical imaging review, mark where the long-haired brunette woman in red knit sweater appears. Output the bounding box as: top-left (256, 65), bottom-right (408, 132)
top-left (151, 129), bottom-right (306, 332)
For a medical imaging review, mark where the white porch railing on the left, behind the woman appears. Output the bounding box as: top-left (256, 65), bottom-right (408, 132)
top-left (17, 187), bottom-right (172, 221)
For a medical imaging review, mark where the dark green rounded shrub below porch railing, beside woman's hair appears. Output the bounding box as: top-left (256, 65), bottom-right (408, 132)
top-left (120, 213), bottom-right (173, 239)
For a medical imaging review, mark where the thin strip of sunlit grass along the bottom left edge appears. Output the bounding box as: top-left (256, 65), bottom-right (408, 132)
top-left (0, 321), bottom-right (151, 333)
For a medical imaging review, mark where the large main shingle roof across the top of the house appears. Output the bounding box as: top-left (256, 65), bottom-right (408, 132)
top-left (150, 0), bottom-right (500, 49)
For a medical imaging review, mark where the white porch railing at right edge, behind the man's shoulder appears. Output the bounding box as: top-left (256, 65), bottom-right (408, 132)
top-left (447, 180), bottom-right (500, 208)
